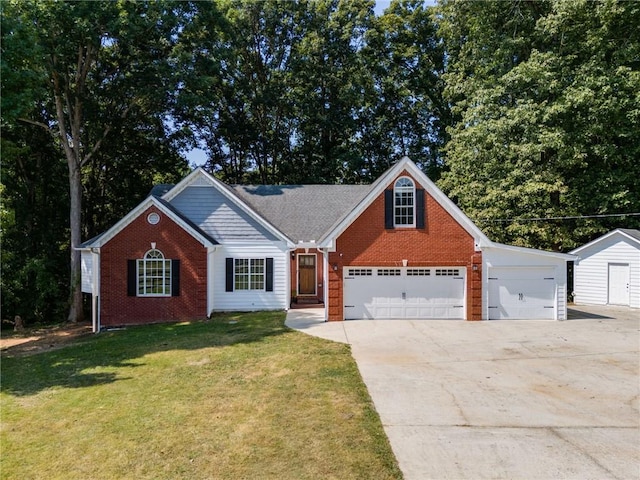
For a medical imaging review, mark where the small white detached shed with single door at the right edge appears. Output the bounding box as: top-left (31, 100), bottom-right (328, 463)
top-left (571, 228), bottom-right (640, 308)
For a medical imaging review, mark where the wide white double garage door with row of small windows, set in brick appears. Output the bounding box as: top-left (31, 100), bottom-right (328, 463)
top-left (344, 267), bottom-right (465, 320)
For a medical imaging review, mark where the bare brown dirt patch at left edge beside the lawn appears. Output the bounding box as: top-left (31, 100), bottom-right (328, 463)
top-left (0, 323), bottom-right (91, 357)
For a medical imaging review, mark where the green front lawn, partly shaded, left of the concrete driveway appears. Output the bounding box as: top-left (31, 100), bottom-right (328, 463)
top-left (0, 312), bottom-right (402, 480)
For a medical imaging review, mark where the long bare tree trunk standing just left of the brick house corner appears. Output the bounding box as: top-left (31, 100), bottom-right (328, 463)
top-left (67, 161), bottom-right (83, 322)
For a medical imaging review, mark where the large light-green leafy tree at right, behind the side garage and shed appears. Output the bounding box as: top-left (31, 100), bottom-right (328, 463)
top-left (438, 1), bottom-right (640, 250)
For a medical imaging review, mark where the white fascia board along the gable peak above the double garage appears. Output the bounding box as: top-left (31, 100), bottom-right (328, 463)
top-left (318, 157), bottom-right (492, 248)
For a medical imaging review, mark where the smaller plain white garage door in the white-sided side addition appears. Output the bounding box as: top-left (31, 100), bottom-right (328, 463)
top-left (489, 267), bottom-right (556, 320)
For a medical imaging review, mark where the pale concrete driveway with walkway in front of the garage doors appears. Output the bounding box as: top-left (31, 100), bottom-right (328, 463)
top-left (287, 307), bottom-right (640, 480)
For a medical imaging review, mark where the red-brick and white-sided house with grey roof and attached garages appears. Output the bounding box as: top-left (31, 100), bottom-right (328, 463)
top-left (80, 158), bottom-right (573, 330)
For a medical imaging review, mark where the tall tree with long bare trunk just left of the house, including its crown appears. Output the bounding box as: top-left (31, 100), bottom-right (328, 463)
top-left (3, 1), bottom-right (189, 321)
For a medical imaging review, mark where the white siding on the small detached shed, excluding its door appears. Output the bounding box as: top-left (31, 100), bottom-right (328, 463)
top-left (573, 235), bottom-right (640, 308)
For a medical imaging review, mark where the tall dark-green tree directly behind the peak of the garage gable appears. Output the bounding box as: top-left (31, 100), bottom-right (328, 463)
top-left (360, 0), bottom-right (451, 180)
